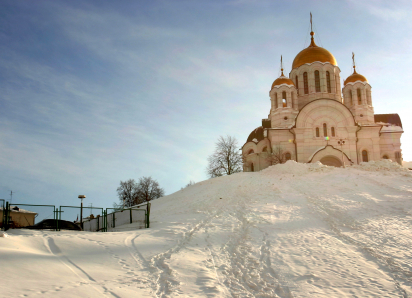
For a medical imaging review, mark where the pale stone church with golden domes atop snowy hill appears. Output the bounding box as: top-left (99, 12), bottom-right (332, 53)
top-left (242, 24), bottom-right (403, 172)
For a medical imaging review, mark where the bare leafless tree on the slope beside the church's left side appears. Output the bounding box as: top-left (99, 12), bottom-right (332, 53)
top-left (206, 136), bottom-right (242, 178)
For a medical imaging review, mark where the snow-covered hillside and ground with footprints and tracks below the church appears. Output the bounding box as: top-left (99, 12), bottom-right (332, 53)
top-left (0, 161), bottom-right (412, 298)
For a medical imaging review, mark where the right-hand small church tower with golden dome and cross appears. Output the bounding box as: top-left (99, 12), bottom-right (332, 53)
top-left (343, 53), bottom-right (375, 124)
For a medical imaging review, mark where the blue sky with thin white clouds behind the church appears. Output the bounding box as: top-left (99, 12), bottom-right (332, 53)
top-left (0, 0), bottom-right (412, 218)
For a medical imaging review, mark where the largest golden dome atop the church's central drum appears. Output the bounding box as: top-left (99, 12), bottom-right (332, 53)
top-left (292, 32), bottom-right (338, 69)
